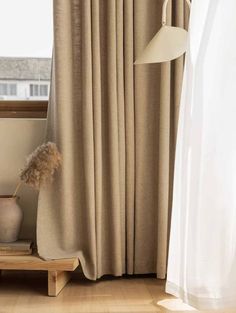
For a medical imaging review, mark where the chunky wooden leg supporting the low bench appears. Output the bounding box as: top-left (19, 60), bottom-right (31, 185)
top-left (48, 271), bottom-right (71, 297)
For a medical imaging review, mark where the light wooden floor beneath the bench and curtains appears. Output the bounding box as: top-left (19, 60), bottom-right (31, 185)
top-left (0, 271), bottom-right (236, 313)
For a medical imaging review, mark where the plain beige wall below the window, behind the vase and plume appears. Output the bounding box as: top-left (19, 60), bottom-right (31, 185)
top-left (0, 119), bottom-right (45, 238)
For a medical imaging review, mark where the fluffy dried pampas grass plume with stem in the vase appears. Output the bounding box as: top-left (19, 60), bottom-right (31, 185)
top-left (14, 142), bottom-right (61, 196)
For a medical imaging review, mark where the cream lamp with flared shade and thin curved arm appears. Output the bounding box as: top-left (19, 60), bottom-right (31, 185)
top-left (134, 0), bottom-right (191, 65)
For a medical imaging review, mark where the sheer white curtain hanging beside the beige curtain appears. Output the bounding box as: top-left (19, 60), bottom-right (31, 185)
top-left (166, 0), bottom-right (236, 309)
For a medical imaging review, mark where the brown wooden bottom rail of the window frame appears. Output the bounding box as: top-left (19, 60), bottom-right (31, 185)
top-left (0, 100), bottom-right (48, 119)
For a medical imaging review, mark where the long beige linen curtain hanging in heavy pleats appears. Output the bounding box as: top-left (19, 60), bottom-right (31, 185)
top-left (37, 0), bottom-right (188, 279)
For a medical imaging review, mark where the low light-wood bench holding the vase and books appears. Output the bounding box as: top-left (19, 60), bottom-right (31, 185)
top-left (0, 255), bottom-right (79, 297)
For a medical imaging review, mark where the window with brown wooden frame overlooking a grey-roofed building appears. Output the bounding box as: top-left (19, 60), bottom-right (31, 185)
top-left (0, 0), bottom-right (53, 117)
